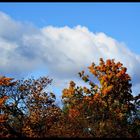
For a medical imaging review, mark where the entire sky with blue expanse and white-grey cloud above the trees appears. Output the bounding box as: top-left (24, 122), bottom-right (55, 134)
top-left (0, 2), bottom-right (140, 103)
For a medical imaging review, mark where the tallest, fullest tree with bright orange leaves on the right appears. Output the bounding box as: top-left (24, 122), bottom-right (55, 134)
top-left (62, 58), bottom-right (139, 137)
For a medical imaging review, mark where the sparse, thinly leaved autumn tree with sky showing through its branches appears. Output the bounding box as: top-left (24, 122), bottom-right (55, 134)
top-left (0, 77), bottom-right (59, 137)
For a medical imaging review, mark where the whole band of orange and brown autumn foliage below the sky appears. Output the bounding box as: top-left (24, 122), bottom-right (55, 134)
top-left (0, 58), bottom-right (140, 138)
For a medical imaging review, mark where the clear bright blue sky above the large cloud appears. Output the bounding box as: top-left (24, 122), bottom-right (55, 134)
top-left (0, 2), bottom-right (140, 53)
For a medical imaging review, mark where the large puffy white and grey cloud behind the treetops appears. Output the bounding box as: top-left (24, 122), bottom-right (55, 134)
top-left (0, 12), bottom-right (140, 95)
